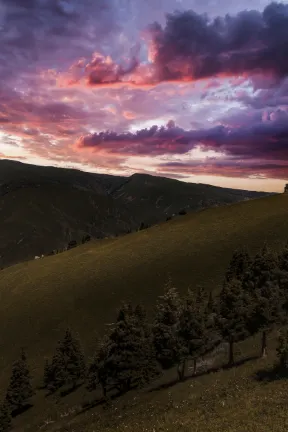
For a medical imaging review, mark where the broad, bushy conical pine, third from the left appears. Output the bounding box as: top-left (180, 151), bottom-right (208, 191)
top-left (89, 304), bottom-right (159, 396)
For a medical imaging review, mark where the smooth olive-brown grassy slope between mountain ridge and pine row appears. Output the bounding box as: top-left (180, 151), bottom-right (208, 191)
top-left (0, 195), bottom-right (288, 392)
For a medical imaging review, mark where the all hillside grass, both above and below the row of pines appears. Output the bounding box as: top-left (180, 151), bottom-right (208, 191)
top-left (0, 195), bottom-right (288, 432)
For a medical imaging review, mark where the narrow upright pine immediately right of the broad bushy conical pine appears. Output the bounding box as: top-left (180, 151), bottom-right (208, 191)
top-left (153, 284), bottom-right (182, 369)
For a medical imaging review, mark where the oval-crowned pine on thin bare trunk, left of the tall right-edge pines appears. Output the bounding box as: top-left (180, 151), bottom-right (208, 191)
top-left (217, 279), bottom-right (250, 366)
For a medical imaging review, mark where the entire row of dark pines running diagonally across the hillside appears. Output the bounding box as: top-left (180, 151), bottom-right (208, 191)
top-left (0, 244), bottom-right (288, 432)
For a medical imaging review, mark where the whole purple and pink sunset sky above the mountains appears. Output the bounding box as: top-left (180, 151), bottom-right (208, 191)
top-left (0, 0), bottom-right (288, 191)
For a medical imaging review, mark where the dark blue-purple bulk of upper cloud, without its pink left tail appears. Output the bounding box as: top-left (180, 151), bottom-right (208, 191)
top-left (151, 3), bottom-right (288, 81)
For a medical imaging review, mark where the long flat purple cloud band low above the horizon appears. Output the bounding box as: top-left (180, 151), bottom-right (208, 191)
top-left (77, 110), bottom-right (288, 160)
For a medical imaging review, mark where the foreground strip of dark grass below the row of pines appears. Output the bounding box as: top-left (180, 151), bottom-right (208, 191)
top-left (10, 333), bottom-right (288, 432)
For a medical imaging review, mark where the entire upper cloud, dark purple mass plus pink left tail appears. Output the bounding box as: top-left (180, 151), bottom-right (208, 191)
top-left (59, 3), bottom-right (288, 86)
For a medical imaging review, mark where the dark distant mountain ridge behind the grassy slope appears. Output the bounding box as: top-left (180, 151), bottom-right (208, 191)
top-left (0, 160), bottom-right (269, 267)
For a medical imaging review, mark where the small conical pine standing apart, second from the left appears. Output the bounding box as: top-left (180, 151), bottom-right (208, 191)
top-left (44, 329), bottom-right (86, 391)
